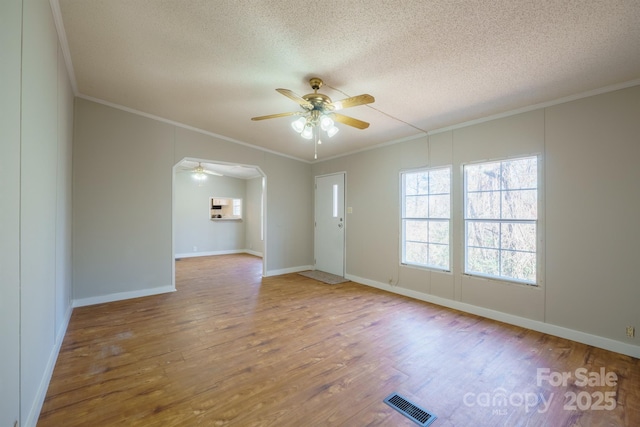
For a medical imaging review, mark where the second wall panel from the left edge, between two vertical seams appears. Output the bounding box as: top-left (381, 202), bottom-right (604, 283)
top-left (20, 0), bottom-right (58, 425)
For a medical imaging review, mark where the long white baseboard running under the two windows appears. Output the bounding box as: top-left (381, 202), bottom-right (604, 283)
top-left (345, 274), bottom-right (640, 358)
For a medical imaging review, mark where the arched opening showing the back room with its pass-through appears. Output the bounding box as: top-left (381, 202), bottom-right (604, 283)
top-left (172, 157), bottom-right (267, 288)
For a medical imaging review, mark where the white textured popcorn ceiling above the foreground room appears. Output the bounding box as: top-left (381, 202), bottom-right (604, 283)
top-left (53, 0), bottom-right (640, 161)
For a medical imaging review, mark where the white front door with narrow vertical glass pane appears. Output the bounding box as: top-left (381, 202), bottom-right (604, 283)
top-left (314, 173), bottom-right (345, 277)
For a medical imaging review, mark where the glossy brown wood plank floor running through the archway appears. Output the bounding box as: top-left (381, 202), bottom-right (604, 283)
top-left (38, 255), bottom-right (640, 427)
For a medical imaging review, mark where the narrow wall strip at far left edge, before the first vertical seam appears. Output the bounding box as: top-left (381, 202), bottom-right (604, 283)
top-left (0, 0), bottom-right (22, 426)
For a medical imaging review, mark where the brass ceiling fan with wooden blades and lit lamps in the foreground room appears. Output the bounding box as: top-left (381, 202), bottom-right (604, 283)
top-left (251, 77), bottom-right (375, 159)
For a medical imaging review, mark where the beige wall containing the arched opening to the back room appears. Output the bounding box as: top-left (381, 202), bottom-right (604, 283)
top-left (73, 99), bottom-right (313, 305)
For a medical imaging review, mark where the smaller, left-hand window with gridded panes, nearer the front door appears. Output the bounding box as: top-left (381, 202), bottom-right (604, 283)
top-left (401, 167), bottom-right (451, 271)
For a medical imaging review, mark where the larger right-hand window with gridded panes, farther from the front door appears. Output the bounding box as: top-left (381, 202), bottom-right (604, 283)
top-left (464, 157), bottom-right (538, 284)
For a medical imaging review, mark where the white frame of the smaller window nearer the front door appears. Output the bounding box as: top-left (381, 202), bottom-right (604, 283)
top-left (399, 165), bottom-right (453, 272)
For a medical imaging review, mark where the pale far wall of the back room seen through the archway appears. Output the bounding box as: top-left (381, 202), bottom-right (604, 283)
top-left (173, 173), bottom-right (251, 257)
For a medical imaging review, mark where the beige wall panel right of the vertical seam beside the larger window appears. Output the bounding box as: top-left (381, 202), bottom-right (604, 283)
top-left (546, 86), bottom-right (640, 345)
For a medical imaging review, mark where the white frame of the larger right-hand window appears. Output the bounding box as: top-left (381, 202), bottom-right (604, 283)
top-left (462, 155), bottom-right (543, 286)
